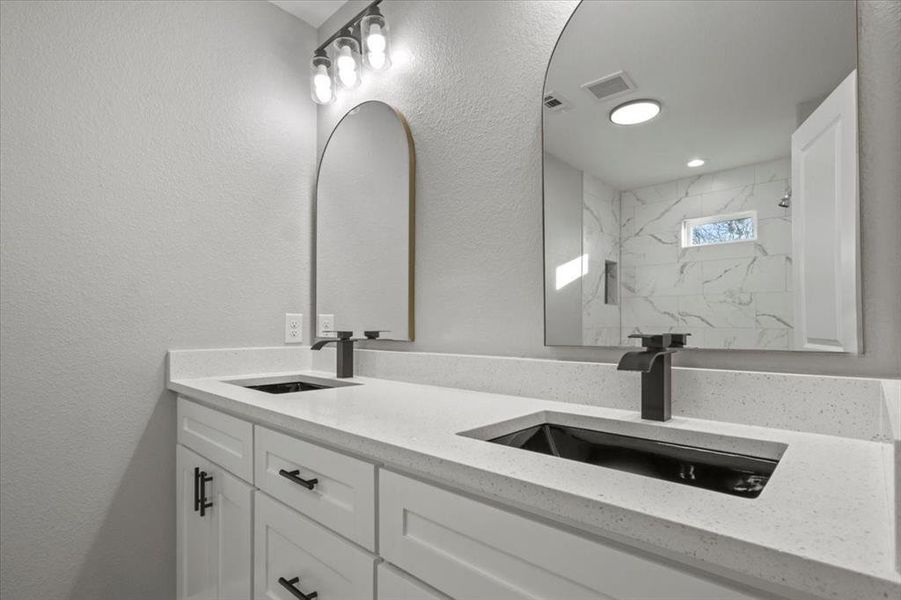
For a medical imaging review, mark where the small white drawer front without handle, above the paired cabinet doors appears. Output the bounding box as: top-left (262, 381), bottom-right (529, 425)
top-left (178, 396), bottom-right (253, 483)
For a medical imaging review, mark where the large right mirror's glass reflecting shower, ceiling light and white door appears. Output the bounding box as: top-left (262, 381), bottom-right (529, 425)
top-left (543, 0), bottom-right (861, 353)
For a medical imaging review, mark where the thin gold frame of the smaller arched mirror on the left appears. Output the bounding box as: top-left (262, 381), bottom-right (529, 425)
top-left (310, 100), bottom-right (416, 342)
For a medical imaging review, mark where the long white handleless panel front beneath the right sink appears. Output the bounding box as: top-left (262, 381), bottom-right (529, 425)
top-left (379, 470), bottom-right (754, 600)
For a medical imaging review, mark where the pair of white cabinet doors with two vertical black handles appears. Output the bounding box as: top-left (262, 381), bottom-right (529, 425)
top-left (176, 444), bottom-right (253, 600)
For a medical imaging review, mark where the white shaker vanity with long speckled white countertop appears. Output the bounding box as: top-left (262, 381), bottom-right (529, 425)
top-left (169, 350), bottom-right (901, 600)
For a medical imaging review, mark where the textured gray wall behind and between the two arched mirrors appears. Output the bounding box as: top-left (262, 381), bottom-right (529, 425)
top-left (318, 0), bottom-right (901, 376)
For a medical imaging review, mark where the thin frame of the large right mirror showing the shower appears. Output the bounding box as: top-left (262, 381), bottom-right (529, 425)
top-left (538, 0), bottom-right (866, 357)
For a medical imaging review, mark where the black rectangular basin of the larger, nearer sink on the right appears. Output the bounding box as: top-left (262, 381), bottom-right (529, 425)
top-left (488, 423), bottom-right (779, 498)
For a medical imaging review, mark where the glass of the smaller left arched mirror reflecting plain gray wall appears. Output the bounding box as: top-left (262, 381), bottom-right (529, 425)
top-left (316, 102), bottom-right (415, 340)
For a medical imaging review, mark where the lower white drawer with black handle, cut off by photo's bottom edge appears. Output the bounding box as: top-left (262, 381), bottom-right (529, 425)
top-left (254, 492), bottom-right (375, 600)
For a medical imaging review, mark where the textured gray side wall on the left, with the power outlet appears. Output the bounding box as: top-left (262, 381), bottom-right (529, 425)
top-left (0, 2), bottom-right (316, 600)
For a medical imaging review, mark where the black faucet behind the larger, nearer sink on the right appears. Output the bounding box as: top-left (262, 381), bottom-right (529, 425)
top-left (616, 333), bottom-right (691, 421)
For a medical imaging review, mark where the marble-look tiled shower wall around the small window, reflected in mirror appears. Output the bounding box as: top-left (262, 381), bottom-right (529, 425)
top-left (620, 157), bottom-right (792, 349)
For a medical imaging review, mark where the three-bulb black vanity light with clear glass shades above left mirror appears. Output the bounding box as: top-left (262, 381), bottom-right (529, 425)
top-left (310, 0), bottom-right (391, 104)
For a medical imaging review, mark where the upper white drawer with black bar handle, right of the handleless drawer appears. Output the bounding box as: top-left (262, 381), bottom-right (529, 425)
top-left (254, 426), bottom-right (375, 551)
